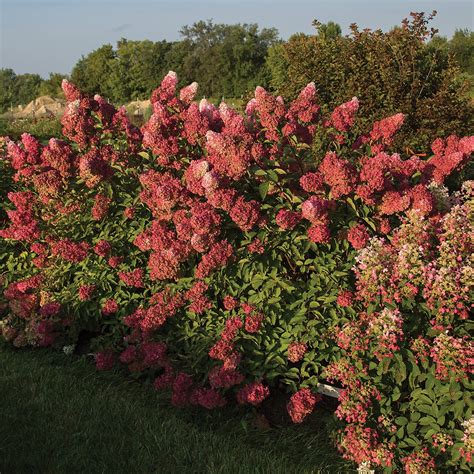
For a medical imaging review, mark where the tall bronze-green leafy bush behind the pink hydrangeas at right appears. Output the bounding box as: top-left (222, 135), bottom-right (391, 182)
top-left (268, 13), bottom-right (474, 153)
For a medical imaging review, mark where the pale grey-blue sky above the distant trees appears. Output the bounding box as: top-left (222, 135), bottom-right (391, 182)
top-left (0, 0), bottom-right (473, 77)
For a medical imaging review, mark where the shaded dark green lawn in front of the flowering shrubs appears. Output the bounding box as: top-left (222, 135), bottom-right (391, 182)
top-left (0, 344), bottom-right (351, 474)
